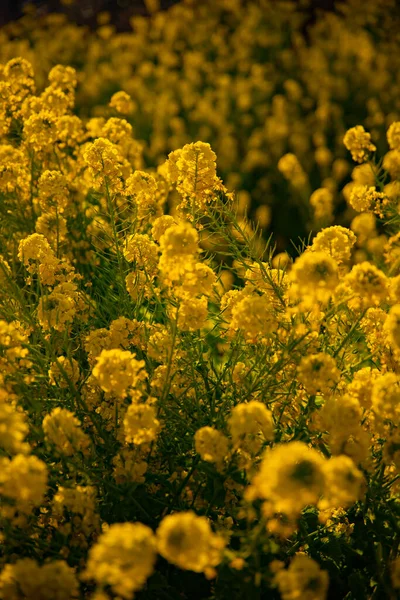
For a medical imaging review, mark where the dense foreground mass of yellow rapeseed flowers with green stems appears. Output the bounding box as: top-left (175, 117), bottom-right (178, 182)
top-left (0, 47), bottom-right (400, 600)
